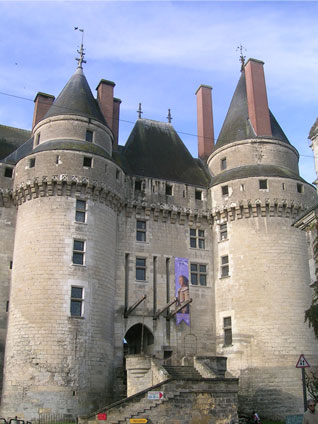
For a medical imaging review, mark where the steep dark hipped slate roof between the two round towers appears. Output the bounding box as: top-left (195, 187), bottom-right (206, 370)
top-left (121, 119), bottom-right (210, 186)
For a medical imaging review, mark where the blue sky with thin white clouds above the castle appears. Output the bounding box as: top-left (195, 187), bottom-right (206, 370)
top-left (0, 1), bottom-right (318, 182)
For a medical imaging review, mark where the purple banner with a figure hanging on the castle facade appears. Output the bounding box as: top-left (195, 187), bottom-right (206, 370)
top-left (174, 258), bottom-right (190, 325)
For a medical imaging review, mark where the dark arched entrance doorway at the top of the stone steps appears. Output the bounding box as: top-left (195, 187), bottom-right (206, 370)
top-left (124, 323), bottom-right (154, 356)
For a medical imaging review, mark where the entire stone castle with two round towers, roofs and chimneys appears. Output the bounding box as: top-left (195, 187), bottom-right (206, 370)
top-left (0, 48), bottom-right (318, 422)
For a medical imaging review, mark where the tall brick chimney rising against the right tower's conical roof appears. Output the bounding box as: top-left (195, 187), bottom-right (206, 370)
top-left (245, 59), bottom-right (272, 136)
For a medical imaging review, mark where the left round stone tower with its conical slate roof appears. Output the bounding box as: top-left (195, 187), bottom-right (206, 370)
top-left (1, 61), bottom-right (123, 419)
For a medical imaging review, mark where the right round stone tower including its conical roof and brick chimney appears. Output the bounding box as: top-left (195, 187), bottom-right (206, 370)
top-left (208, 59), bottom-right (318, 417)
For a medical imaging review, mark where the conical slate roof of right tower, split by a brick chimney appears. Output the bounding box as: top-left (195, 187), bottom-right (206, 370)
top-left (214, 71), bottom-right (290, 150)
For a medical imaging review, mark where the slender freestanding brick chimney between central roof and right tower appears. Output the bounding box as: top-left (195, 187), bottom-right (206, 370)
top-left (195, 84), bottom-right (214, 161)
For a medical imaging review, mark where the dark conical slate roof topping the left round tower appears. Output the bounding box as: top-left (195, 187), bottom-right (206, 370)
top-left (44, 68), bottom-right (107, 125)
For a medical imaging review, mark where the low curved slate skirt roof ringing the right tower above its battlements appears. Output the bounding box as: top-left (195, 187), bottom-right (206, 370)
top-left (211, 165), bottom-right (308, 186)
